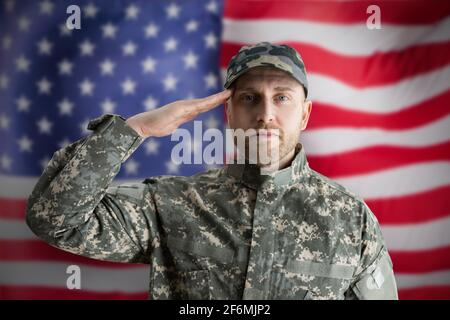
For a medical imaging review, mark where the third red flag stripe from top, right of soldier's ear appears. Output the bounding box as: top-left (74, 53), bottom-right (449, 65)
top-left (307, 90), bottom-right (450, 130)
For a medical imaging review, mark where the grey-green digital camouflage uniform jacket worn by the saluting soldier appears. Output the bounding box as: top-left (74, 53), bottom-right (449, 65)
top-left (27, 114), bottom-right (397, 299)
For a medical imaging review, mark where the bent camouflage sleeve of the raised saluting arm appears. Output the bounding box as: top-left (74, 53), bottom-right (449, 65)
top-left (26, 114), bottom-right (156, 263)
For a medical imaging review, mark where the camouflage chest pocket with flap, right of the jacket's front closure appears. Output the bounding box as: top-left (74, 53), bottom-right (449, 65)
top-left (273, 260), bottom-right (356, 300)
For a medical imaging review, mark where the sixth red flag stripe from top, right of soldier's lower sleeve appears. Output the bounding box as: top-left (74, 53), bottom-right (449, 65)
top-left (389, 246), bottom-right (450, 274)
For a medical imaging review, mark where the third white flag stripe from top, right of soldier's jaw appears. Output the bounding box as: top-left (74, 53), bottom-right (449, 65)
top-left (301, 115), bottom-right (450, 156)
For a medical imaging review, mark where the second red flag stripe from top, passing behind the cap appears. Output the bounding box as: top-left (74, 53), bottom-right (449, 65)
top-left (220, 41), bottom-right (450, 88)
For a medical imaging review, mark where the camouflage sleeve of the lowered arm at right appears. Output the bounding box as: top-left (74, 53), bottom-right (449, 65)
top-left (346, 204), bottom-right (398, 300)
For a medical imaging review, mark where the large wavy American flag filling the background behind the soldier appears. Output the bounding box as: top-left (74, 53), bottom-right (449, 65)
top-left (0, 0), bottom-right (450, 299)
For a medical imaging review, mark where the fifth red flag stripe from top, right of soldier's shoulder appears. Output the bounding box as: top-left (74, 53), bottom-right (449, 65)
top-left (365, 186), bottom-right (450, 225)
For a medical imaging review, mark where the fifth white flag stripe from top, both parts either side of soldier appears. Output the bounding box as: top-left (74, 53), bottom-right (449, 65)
top-left (0, 217), bottom-right (450, 251)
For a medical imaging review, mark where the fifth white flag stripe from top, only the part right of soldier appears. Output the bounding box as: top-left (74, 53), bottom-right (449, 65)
top-left (381, 217), bottom-right (450, 251)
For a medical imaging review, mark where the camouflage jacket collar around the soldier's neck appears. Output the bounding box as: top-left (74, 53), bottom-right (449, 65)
top-left (225, 143), bottom-right (309, 189)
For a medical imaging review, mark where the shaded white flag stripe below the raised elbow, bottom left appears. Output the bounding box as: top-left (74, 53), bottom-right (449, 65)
top-left (0, 261), bottom-right (149, 293)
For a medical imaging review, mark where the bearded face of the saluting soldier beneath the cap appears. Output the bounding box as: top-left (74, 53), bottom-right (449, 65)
top-left (225, 67), bottom-right (312, 169)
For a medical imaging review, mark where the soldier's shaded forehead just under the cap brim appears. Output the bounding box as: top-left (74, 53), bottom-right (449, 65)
top-left (232, 67), bottom-right (300, 89)
